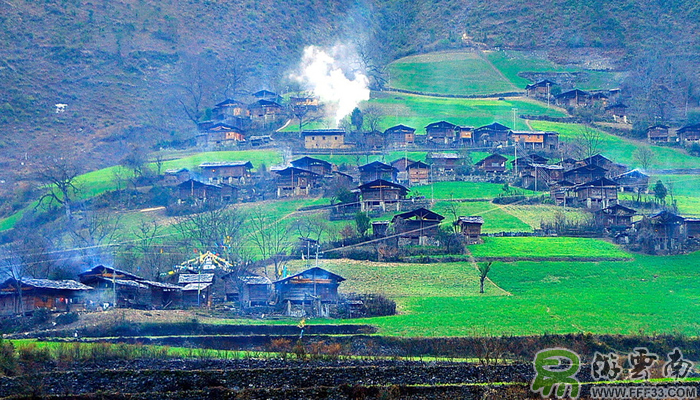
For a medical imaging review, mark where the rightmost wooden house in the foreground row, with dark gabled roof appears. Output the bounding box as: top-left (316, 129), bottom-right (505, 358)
top-left (273, 267), bottom-right (345, 316)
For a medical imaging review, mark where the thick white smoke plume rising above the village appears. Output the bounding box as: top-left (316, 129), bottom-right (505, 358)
top-left (290, 45), bottom-right (369, 126)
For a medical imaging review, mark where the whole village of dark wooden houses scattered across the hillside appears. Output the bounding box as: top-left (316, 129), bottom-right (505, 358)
top-left (0, 81), bottom-right (700, 316)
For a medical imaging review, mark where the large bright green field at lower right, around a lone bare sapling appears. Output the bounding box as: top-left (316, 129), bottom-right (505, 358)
top-left (288, 250), bottom-right (700, 336)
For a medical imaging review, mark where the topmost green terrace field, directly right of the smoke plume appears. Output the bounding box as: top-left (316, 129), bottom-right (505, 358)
top-left (389, 52), bottom-right (513, 95)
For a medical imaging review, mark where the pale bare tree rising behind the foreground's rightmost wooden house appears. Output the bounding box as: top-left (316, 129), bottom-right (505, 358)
top-left (247, 208), bottom-right (292, 278)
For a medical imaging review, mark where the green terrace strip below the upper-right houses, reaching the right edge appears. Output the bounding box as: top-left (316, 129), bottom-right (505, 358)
top-left (530, 121), bottom-right (700, 169)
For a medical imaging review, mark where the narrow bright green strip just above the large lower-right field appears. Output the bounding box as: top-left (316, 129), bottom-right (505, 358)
top-left (469, 237), bottom-right (631, 258)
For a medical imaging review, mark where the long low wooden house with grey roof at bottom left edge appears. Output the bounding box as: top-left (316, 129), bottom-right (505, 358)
top-left (0, 278), bottom-right (92, 316)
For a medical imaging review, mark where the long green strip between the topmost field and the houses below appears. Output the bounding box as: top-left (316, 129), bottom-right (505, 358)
top-left (369, 92), bottom-right (566, 134)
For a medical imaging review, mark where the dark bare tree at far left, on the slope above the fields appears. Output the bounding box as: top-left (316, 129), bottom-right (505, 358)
top-left (37, 158), bottom-right (80, 222)
